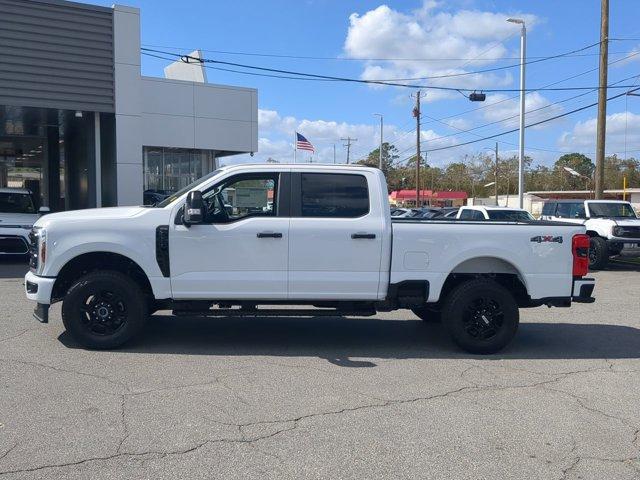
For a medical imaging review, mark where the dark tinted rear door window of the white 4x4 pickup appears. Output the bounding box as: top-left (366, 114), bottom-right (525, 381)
top-left (300, 173), bottom-right (369, 218)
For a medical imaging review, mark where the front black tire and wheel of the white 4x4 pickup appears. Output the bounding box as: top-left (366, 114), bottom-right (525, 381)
top-left (62, 271), bottom-right (148, 349)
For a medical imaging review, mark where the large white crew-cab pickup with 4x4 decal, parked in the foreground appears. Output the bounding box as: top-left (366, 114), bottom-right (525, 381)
top-left (25, 164), bottom-right (594, 353)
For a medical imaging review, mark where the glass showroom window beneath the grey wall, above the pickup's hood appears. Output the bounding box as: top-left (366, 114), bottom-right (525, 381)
top-left (143, 147), bottom-right (216, 194)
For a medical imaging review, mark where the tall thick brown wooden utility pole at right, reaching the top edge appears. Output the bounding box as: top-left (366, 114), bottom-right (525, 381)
top-left (595, 0), bottom-right (609, 199)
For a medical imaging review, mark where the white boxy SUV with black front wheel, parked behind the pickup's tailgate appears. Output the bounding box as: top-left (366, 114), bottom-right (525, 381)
top-left (540, 200), bottom-right (640, 269)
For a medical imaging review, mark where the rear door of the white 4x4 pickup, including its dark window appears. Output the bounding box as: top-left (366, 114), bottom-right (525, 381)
top-left (289, 172), bottom-right (386, 300)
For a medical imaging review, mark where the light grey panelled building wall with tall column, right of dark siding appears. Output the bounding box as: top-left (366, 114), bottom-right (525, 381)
top-left (113, 5), bottom-right (258, 205)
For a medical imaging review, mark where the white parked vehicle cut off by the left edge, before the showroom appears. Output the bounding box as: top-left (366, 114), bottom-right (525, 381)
top-left (0, 188), bottom-right (49, 256)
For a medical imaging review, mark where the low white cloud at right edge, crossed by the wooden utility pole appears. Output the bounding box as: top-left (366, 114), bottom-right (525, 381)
top-left (558, 112), bottom-right (640, 155)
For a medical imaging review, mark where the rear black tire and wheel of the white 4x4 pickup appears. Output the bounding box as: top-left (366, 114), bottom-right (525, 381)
top-left (442, 278), bottom-right (520, 354)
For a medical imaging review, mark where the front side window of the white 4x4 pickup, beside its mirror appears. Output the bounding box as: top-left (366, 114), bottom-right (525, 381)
top-left (203, 173), bottom-right (278, 223)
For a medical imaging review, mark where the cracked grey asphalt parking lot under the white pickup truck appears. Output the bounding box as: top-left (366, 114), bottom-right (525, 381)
top-left (0, 262), bottom-right (640, 480)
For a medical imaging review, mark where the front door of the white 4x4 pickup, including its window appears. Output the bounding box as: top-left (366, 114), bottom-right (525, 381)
top-left (169, 172), bottom-right (290, 300)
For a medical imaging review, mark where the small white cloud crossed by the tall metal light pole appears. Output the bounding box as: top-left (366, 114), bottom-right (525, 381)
top-left (482, 92), bottom-right (563, 129)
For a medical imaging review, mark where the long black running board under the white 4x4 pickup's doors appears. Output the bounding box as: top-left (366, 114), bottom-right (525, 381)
top-left (173, 308), bottom-right (377, 318)
